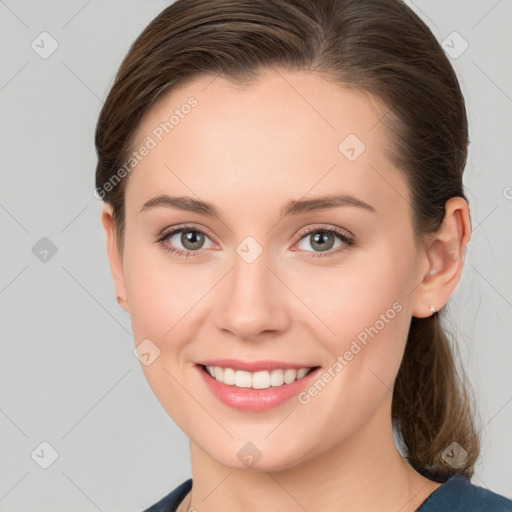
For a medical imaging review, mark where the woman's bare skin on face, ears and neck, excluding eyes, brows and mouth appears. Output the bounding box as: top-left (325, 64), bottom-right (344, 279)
top-left (102, 70), bottom-right (470, 512)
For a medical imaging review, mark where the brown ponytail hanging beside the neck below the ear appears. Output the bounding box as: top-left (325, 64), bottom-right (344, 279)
top-left (392, 313), bottom-right (480, 482)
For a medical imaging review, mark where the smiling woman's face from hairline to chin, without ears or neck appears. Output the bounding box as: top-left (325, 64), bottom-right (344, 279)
top-left (103, 71), bottom-right (426, 470)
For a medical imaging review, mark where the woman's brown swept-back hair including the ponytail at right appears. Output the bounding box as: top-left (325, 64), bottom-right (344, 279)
top-left (96, 0), bottom-right (479, 481)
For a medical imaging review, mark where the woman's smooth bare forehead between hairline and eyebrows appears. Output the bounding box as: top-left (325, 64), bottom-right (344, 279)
top-left (126, 71), bottom-right (408, 220)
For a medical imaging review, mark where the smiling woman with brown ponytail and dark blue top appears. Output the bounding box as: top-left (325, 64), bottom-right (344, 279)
top-left (96, 0), bottom-right (512, 512)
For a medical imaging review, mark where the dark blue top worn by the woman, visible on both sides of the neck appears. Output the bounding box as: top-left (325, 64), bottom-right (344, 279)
top-left (144, 475), bottom-right (512, 512)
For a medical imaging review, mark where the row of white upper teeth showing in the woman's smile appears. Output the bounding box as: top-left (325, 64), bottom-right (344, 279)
top-left (206, 366), bottom-right (311, 389)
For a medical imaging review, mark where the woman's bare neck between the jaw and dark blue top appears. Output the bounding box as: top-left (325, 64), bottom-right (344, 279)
top-left (185, 396), bottom-right (440, 512)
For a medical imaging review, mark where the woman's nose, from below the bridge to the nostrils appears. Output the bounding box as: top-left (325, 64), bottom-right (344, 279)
top-left (215, 248), bottom-right (293, 340)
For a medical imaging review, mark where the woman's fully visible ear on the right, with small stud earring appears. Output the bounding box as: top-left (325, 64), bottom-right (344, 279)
top-left (412, 197), bottom-right (471, 318)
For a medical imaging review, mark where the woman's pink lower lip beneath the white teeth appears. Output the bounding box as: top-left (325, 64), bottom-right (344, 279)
top-left (196, 365), bottom-right (320, 412)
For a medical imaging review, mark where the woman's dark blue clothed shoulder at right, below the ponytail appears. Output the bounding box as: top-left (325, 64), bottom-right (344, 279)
top-left (418, 475), bottom-right (512, 512)
